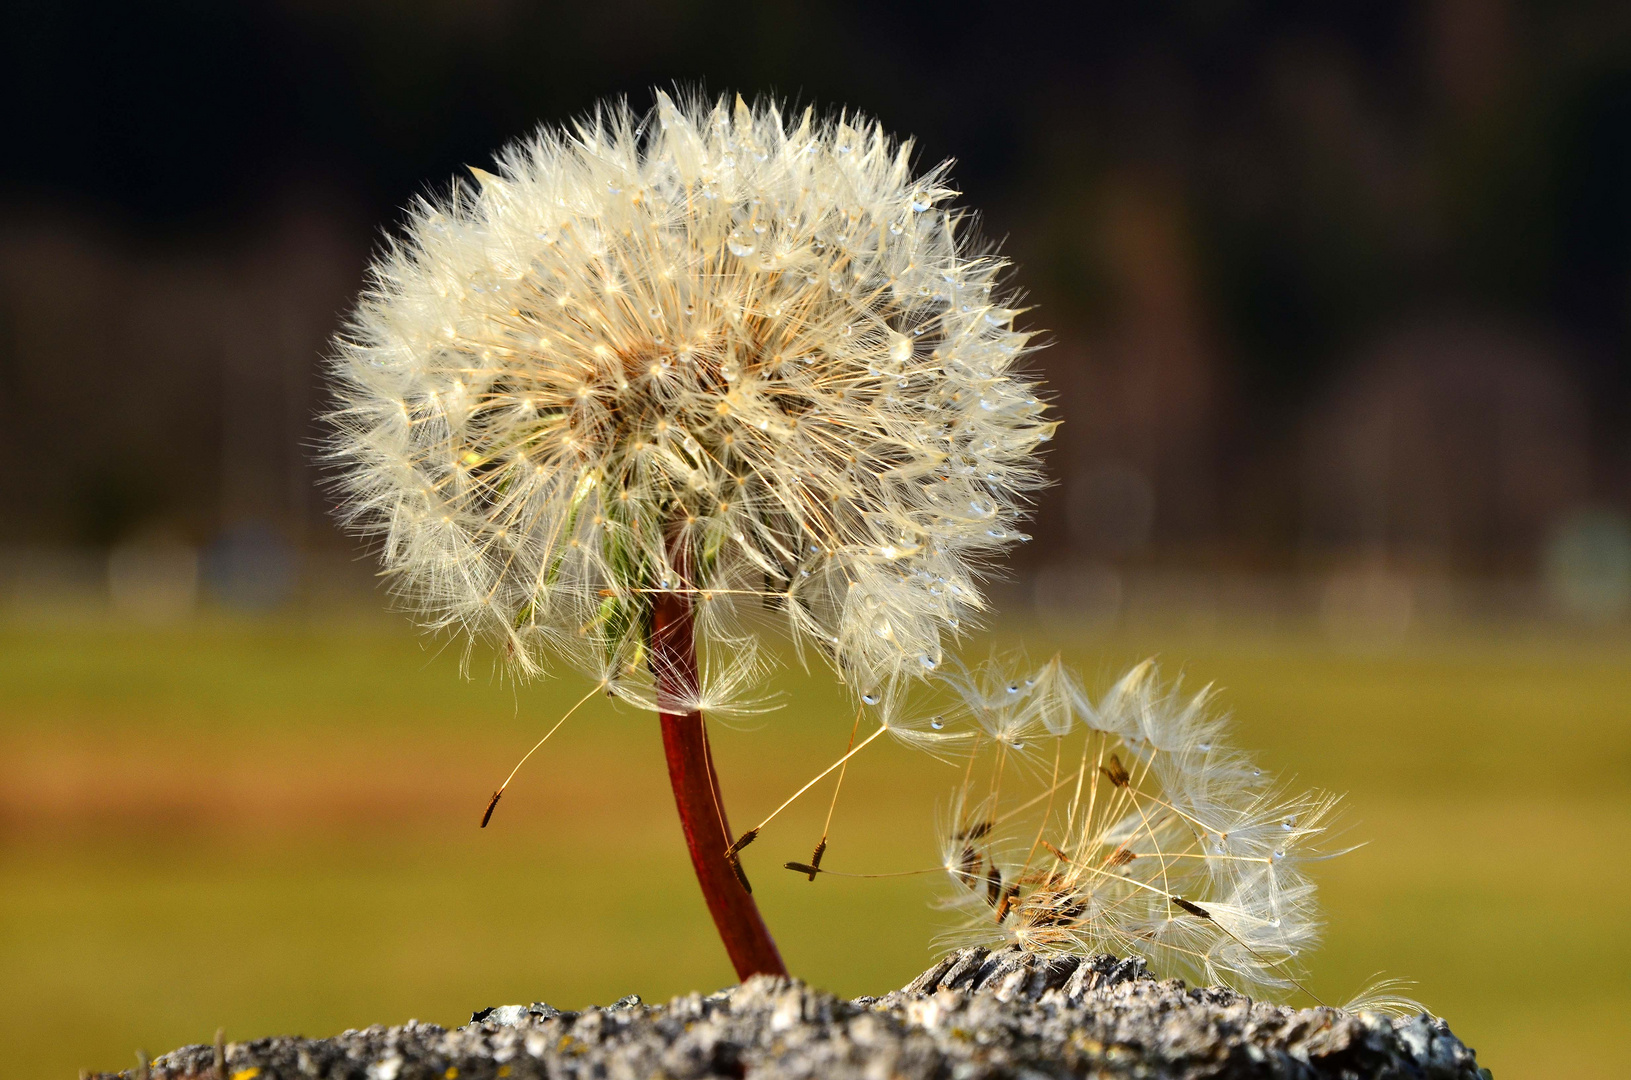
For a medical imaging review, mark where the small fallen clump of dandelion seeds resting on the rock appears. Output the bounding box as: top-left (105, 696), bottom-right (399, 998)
top-left (941, 661), bottom-right (1336, 990)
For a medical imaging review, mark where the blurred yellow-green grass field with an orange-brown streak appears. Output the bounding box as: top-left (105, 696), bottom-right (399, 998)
top-left (0, 620), bottom-right (1631, 1080)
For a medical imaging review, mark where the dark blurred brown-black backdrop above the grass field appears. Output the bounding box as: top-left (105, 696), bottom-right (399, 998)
top-left (0, 0), bottom-right (1631, 607)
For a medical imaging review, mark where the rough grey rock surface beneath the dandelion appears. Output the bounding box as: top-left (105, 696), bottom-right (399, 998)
top-left (101, 948), bottom-right (1489, 1080)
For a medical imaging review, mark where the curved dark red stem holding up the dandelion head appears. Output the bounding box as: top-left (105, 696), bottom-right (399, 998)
top-left (651, 592), bottom-right (788, 979)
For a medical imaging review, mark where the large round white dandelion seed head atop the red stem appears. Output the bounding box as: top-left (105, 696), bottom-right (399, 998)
top-left (331, 96), bottom-right (1054, 693)
